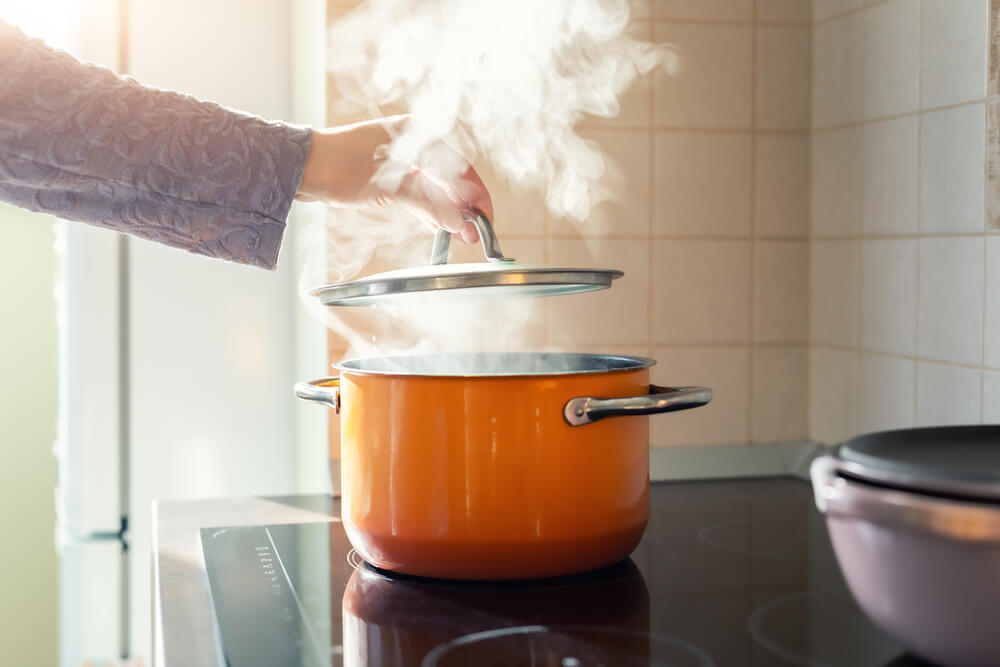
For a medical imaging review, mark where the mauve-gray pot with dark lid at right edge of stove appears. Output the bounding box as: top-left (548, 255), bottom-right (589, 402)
top-left (811, 427), bottom-right (1000, 667)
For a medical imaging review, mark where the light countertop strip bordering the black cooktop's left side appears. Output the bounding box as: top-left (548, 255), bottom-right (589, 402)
top-left (152, 496), bottom-right (336, 667)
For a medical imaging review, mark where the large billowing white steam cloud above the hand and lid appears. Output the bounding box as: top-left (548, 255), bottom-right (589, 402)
top-left (328, 0), bottom-right (676, 221)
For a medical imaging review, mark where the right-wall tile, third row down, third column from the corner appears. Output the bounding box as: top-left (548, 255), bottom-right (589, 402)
top-left (917, 237), bottom-right (985, 366)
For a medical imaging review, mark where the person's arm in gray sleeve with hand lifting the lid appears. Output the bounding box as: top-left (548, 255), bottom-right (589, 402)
top-left (0, 21), bottom-right (493, 268)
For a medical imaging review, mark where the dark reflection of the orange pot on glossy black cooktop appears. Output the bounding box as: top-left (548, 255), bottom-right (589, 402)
top-left (343, 561), bottom-right (650, 667)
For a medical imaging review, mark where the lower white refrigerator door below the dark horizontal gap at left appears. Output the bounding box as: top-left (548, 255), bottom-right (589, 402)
top-left (59, 539), bottom-right (126, 667)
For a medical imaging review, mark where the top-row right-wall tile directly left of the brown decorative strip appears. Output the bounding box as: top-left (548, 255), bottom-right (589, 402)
top-left (920, 0), bottom-right (990, 108)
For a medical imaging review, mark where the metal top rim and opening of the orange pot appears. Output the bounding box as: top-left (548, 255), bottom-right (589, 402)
top-left (333, 352), bottom-right (656, 378)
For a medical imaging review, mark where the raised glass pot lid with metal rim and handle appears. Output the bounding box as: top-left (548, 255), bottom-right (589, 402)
top-left (310, 211), bottom-right (625, 306)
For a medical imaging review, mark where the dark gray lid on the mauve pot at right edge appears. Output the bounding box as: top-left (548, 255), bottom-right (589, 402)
top-left (839, 425), bottom-right (1000, 501)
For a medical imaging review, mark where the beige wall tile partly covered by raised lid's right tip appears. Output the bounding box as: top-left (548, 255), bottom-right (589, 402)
top-left (549, 240), bottom-right (650, 345)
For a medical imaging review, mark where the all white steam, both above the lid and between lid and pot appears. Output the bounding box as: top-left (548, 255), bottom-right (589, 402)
top-left (301, 0), bottom-right (676, 366)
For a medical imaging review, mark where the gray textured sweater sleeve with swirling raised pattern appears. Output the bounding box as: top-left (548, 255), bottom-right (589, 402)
top-left (0, 22), bottom-right (310, 268)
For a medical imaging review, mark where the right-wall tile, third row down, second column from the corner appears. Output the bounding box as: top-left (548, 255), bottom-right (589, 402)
top-left (861, 240), bottom-right (917, 356)
